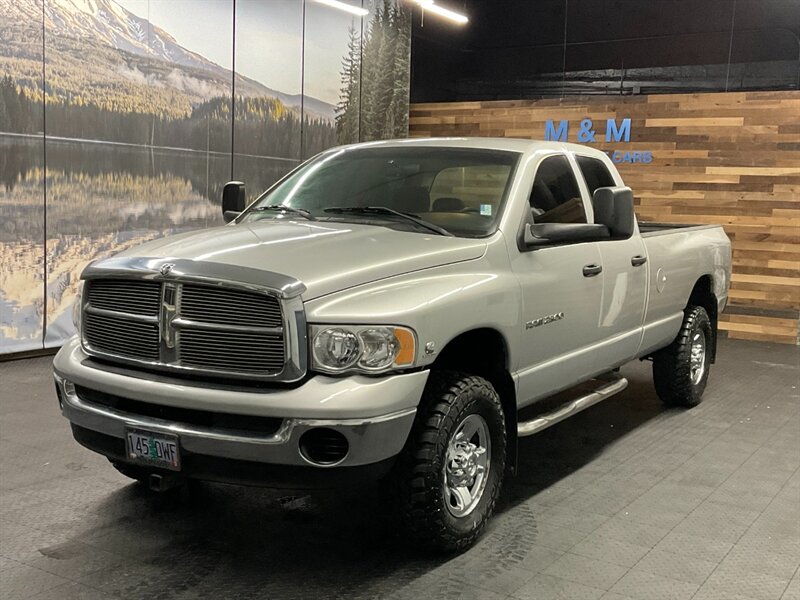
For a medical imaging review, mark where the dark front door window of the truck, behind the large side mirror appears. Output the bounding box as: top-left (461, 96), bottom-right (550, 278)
top-left (530, 156), bottom-right (586, 223)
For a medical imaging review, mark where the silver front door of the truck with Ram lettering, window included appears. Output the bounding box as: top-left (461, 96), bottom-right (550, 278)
top-left (512, 154), bottom-right (603, 405)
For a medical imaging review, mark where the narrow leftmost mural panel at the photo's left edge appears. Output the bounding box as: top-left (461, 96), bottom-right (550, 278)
top-left (0, 0), bottom-right (45, 354)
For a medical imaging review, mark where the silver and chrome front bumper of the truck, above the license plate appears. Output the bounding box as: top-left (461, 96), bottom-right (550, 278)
top-left (54, 340), bottom-right (428, 468)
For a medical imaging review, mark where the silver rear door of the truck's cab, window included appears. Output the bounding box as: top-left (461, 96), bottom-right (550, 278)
top-left (575, 155), bottom-right (648, 369)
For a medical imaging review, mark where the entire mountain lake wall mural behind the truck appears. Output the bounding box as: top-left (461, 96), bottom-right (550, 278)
top-left (0, 0), bottom-right (411, 353)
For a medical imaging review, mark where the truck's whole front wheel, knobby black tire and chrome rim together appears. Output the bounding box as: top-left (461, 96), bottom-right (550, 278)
top-left (394, 371), bottom-right (506, 550)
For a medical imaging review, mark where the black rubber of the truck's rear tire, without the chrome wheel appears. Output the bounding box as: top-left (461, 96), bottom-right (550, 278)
top-left (653, 306), bottom-right (714, 408)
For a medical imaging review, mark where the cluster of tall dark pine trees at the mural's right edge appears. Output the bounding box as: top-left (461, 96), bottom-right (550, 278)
top-left (336, 0), bottom-right (411, 143)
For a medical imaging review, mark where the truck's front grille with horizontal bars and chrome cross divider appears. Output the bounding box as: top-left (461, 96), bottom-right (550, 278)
top-left (83, 279), bottom-right (288, 377)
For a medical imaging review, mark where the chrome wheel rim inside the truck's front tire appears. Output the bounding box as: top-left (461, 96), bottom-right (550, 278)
top-left (444, 414), bottom-right (492, 517)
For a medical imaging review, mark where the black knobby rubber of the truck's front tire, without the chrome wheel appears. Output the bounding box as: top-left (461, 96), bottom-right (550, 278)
top-left (390, 371), bottom-right (506, 551)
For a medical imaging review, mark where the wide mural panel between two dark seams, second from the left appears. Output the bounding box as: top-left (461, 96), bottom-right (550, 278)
top-left (45, 0), bottom-right (233, 346)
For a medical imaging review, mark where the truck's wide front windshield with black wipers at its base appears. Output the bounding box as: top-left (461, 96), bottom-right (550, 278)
top-left (240, 146), bottom-right (519, 237)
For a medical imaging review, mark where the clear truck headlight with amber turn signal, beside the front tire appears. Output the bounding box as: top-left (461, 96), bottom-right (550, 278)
top-left (311, 325), bottom-right (416, 373)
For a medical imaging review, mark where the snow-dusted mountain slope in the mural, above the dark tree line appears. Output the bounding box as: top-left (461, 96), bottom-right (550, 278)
top-left (0, 0), bottom-right (334, 119)
